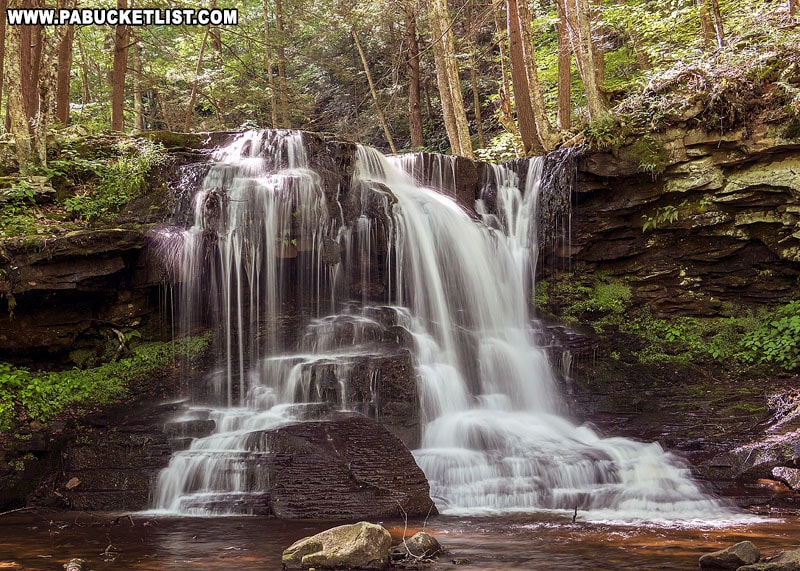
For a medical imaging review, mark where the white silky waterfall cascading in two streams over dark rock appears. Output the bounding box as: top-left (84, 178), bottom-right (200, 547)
top-left (156, 133), bottom-right (727, 520)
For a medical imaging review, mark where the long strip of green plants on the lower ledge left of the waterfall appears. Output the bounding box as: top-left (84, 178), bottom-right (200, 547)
top-left (0, 335), bottom-right (210, 431)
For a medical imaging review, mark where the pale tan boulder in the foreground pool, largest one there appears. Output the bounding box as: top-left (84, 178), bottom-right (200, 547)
top-left (282, 521), bottom-right (392, 569)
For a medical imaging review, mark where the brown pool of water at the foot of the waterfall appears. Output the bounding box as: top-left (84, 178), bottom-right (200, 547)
top-left (0, 512), bottom-right (800, 571)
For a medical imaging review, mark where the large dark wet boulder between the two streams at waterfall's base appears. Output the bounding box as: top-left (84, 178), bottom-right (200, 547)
top-left (263, 413), bottom-right (437, 519)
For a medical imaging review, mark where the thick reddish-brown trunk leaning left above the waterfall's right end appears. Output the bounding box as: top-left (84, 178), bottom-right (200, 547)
top-left (506, 0), bottom-right (544, 155)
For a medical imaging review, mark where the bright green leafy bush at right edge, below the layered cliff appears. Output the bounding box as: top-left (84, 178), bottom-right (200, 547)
top-left (741, 301), bottom-right (800, 371)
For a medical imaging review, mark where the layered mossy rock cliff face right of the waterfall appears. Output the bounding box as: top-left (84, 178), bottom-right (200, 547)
top-left (568, 120), bottom-right (800, 315)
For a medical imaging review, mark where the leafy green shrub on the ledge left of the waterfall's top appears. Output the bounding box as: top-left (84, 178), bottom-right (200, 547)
top-left (63, 139), bottom-right (166, 222)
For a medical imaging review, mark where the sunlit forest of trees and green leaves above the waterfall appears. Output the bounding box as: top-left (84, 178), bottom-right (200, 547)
top-left (0, 0), bottom-right (800, 174)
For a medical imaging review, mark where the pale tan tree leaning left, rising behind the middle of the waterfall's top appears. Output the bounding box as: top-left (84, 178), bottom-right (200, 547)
top-left (428, 0), bottom-right (473, 158)
